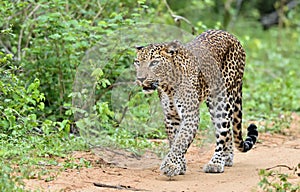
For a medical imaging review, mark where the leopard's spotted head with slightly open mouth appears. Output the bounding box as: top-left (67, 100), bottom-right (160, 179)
top-left (134, 41), bottom-right (182, 94)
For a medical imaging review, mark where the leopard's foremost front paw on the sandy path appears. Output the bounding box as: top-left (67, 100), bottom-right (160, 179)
top-left (160, 152), bottom-right (186, 177)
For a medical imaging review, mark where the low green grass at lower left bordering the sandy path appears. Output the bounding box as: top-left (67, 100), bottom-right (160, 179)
top-left (0, 134), bottom-right (88, 192)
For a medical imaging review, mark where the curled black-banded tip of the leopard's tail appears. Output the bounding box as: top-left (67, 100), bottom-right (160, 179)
top-left (235, 124), bottom-right (258, 152)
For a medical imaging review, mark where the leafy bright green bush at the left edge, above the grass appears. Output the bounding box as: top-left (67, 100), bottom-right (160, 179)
top-left (0, 52), bottom-right (45, 137)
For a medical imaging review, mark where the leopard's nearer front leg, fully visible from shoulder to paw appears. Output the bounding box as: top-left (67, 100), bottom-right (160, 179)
top-left (160, 91), bottom-right (199, 177)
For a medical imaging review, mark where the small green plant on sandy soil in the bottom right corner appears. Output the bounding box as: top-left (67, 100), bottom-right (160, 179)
top-left (258, 169), bottom-right (300, 192)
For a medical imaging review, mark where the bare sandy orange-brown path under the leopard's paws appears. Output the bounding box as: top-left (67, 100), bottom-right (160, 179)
top-left (25, 114), bottom-right (300, 192)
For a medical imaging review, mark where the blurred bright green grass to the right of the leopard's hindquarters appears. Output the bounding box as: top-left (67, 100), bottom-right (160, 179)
top-left (240, 23), bottom-right (300, 132)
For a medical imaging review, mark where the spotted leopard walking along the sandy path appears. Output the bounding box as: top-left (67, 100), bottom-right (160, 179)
top-left (133, 29), bottom-right (258, 178)
